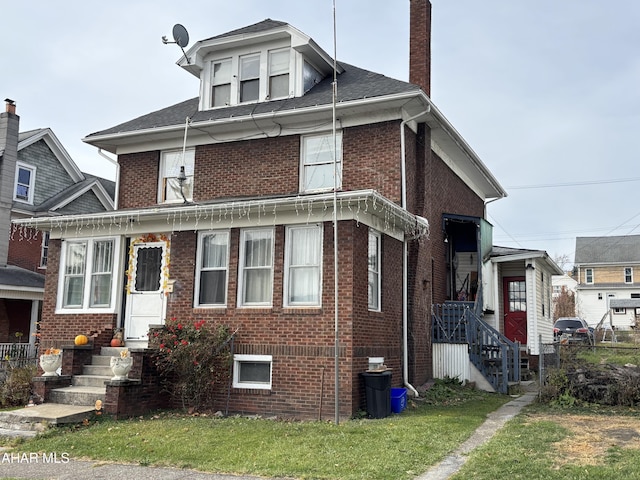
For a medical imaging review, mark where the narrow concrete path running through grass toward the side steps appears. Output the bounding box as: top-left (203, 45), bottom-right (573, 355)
top-left (416, 391), bottom-right (538, 480)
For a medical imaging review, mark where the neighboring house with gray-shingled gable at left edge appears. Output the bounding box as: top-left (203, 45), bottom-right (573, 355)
top-left (0, 100), bottom-right (115, 358)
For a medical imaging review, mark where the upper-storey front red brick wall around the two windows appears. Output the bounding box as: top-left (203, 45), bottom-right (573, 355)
top-left (118, 121), bottom-right (401, 209)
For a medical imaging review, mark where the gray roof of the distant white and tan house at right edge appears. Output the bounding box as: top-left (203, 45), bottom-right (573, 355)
top-left (575, 235), bottom-right (640, 264)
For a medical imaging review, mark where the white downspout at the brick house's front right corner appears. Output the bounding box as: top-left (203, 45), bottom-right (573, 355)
top-left (400, 105), bottom-right (431, 397)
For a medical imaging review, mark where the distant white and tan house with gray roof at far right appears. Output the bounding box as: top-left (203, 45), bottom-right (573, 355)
top-left (574, 235), bottom-right (640, 330)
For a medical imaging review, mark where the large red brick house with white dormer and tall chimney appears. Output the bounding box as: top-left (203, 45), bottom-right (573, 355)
top-left (15, 0), bottom-right (506, 418)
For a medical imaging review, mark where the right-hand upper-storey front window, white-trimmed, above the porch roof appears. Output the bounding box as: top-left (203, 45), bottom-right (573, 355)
top-left (300, 132), bottom-right (342, 192)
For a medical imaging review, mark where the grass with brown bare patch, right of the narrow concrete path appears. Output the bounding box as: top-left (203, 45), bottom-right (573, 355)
top-left (450, 404), bottom-right (640, 480)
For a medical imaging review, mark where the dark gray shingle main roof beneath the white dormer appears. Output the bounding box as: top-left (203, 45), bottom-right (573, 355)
top-left (87, 64), bottom-right (420, 140)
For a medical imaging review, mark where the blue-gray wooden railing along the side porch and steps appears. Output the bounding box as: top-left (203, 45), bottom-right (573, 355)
top-left (432, 302), bottom-right (520, 393)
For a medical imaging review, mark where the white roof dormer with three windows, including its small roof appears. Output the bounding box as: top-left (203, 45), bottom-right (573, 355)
top-left (178, 19), bottom-right (344, 111)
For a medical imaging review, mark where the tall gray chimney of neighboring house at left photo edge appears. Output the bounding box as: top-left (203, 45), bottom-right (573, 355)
top-left (0, 98), bottom-right (20, 267)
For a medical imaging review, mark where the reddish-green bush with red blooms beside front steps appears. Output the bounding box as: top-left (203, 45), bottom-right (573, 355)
top-left (152, 318), bottom-right (231, 410)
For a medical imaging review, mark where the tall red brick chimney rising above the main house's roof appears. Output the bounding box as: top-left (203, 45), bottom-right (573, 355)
top-left (409, 0), bottom-right (431, 97)
